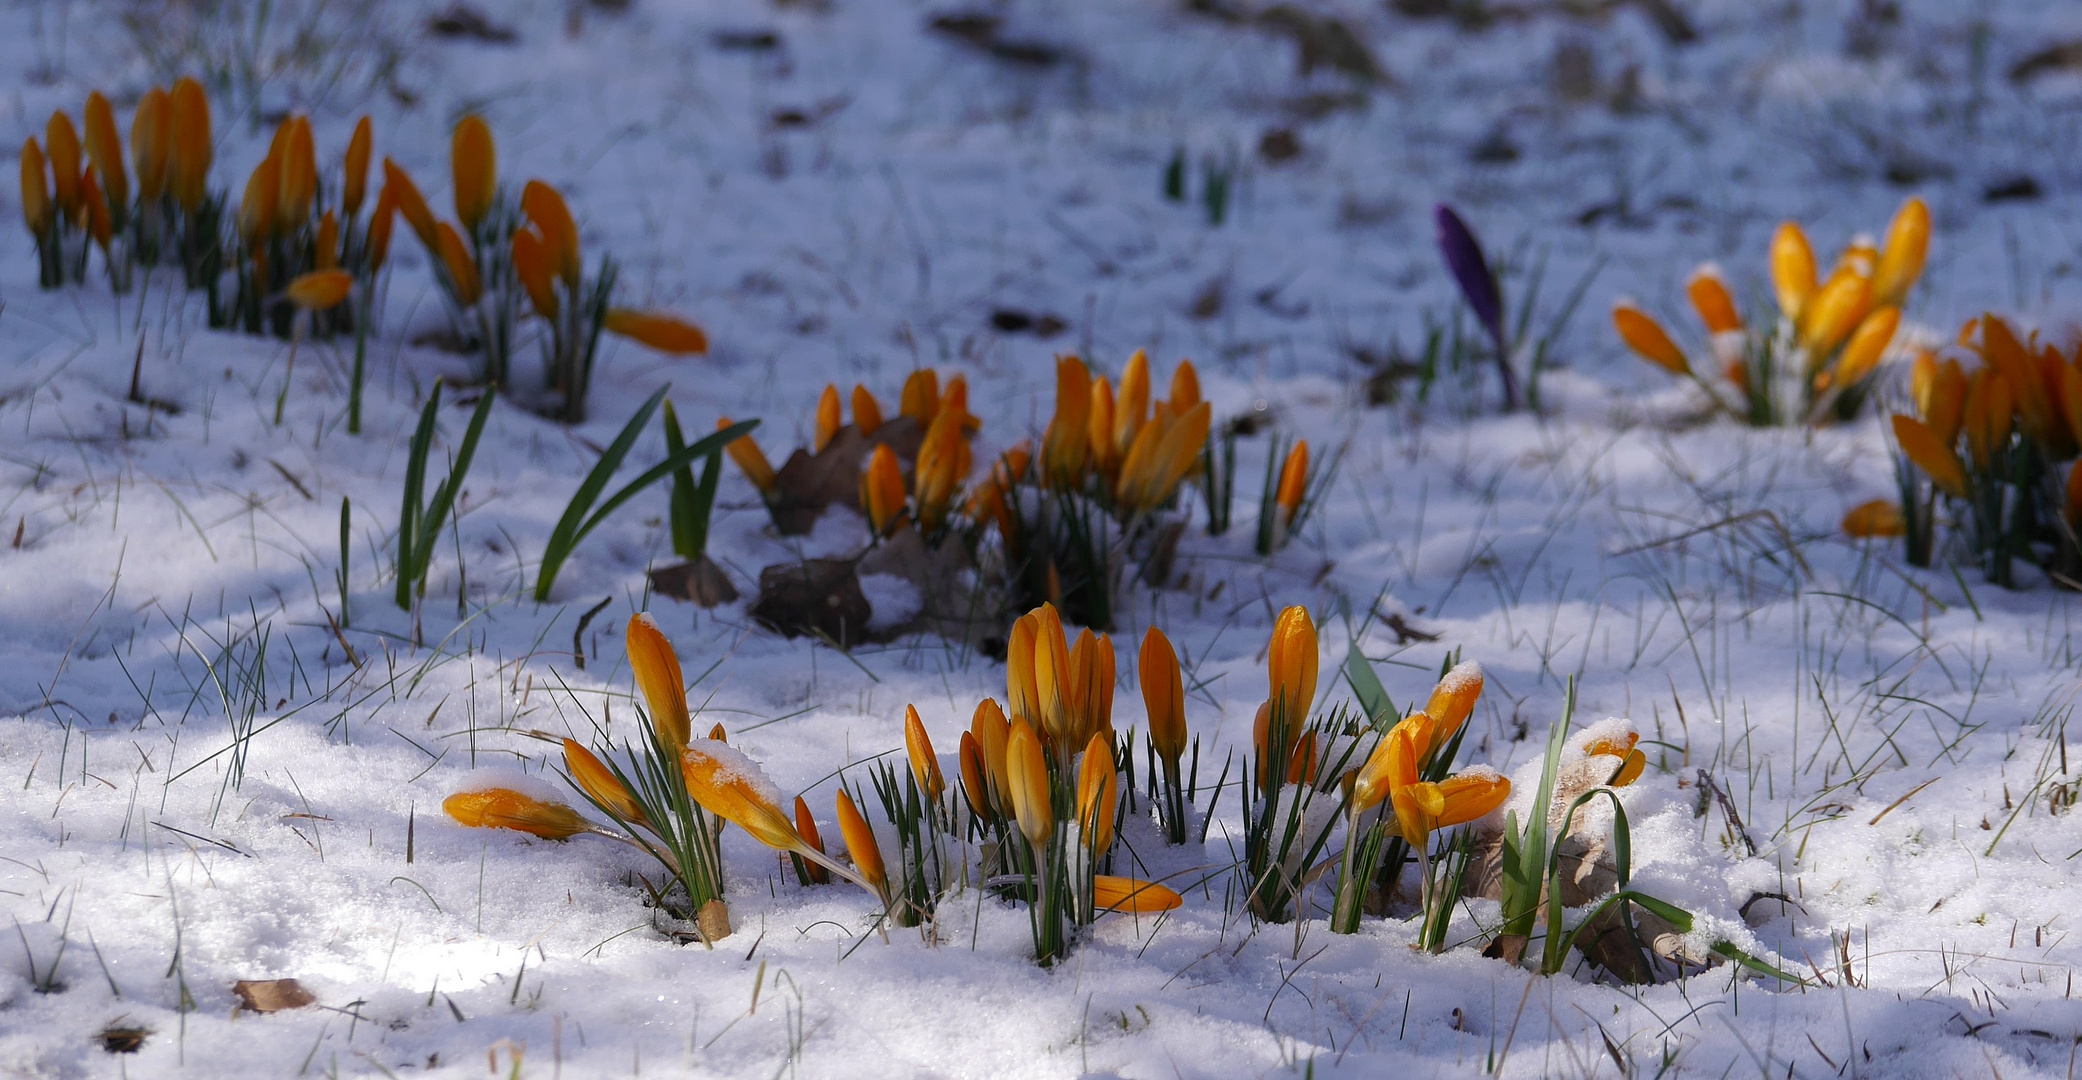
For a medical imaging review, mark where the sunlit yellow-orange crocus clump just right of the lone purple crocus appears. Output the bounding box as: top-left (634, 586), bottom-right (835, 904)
top-left (1611, 198), bottom-right (1930, 425)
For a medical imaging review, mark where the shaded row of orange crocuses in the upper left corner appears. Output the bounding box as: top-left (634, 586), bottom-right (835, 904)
top-left (21, 79), bottom-right (708, 412)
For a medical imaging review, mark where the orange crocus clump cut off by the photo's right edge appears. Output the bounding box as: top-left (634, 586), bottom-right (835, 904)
top-left (1873, 314), bottom-right (2082, 587)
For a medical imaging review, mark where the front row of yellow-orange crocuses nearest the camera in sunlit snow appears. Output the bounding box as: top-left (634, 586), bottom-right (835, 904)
top-left (446, 606), bottom-right (1540, 961)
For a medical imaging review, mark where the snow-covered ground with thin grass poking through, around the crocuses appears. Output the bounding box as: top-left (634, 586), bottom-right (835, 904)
top-left (0, 0), bottom-right (2082, 1078)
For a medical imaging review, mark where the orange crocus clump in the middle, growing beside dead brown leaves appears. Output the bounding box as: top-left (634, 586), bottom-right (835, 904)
top-left (718, 352), bottom-right (1299, 645)
